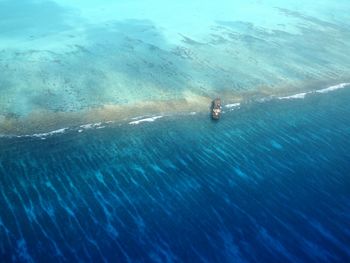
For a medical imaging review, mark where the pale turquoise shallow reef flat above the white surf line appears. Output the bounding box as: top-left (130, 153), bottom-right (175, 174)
top-left (0, 0), bottom-right (350, 134)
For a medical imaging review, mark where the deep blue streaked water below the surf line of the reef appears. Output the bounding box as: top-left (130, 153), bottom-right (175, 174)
top-left (0, 89), bottom-right (350, 262)
